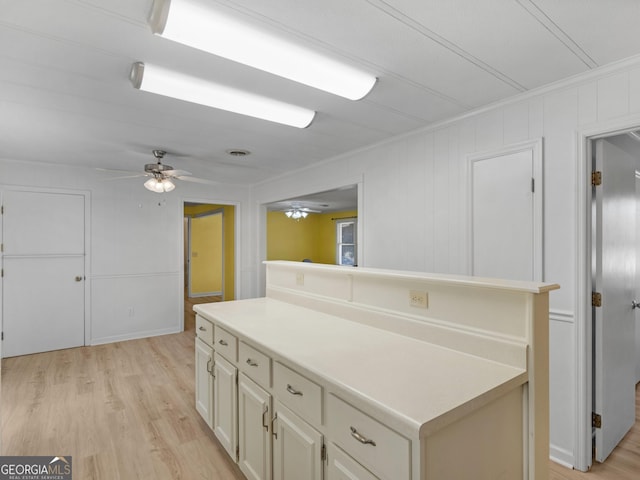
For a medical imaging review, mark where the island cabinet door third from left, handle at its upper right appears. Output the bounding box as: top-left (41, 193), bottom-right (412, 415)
top-left (238, 373), bottom-right (271, 480)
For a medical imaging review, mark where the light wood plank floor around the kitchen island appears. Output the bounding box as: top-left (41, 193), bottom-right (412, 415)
top-left (0, 299), bottom-right (640, 480)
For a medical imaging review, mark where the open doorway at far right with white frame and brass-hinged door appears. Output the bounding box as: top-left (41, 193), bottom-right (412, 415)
top-left (575, 128), bottom-right (640, 471)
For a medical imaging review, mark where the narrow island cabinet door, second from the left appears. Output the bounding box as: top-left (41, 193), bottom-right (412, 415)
top-left (213, 353), bottom-right (238, 461)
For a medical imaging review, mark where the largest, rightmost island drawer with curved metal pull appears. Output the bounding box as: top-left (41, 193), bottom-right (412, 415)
top-left (327, 395), bottom-right (411, 480)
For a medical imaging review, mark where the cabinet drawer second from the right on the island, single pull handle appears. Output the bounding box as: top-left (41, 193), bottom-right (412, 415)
top-left (273, 362), bottom-right (322, 425)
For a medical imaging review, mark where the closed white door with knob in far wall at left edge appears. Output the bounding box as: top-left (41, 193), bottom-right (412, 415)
top-left (2, 190), bottom-right (85, 357)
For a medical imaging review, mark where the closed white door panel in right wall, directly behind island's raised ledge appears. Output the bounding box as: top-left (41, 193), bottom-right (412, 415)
top-left (470, 141), bottom-right (542, 280)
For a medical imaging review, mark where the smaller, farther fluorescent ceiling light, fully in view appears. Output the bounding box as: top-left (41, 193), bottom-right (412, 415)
top-left (130, 62), bottom-right (316, 128)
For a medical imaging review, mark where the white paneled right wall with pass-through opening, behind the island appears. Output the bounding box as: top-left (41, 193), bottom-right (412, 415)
top-left (254, 58), bottom-right (640, 465)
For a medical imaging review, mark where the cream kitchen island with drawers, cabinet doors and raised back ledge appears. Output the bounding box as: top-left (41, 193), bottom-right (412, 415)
top-left (194, 262), bottom-right (557, 480)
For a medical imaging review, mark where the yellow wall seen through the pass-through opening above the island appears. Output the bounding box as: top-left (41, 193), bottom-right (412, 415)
top-left (267, 210), bottom-right (357, 264)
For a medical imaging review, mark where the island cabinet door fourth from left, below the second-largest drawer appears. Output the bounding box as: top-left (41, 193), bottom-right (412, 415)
top-left (273, 402), bottom-right (323, 480)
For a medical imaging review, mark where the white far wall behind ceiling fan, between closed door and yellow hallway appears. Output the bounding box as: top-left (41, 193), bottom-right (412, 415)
top-left (0, 159), bottom-right (250, 344)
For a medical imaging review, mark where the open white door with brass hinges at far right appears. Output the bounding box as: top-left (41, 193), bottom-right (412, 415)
top-left (593, 138), bottom-right (637, 462)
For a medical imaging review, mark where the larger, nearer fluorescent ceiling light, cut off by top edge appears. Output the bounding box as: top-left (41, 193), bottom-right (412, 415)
top-left (149, 0), bottom-right (377, 100)
